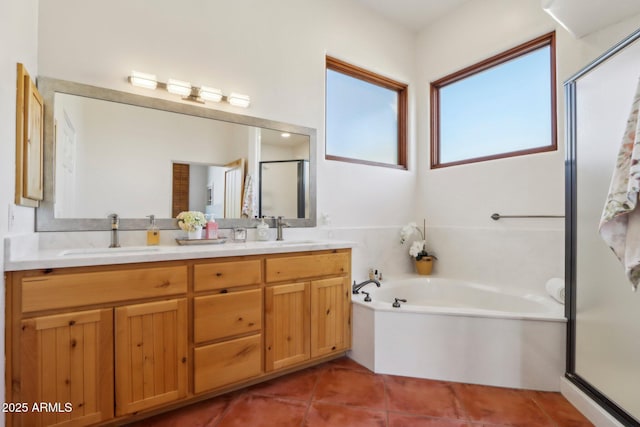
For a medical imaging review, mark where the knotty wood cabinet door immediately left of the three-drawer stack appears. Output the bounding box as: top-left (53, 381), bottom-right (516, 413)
top-left (115, 298), bottom-right (187, 416)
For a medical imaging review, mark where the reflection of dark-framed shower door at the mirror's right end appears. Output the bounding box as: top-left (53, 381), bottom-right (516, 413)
top-left (259, 160), bottom-right (309, 218)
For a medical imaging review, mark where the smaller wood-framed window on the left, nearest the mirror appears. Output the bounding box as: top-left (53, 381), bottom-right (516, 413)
top-left (325, 56), bottom-right (407, 169)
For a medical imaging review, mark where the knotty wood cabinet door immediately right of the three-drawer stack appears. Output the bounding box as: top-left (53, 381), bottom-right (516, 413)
top-left (265, 282), bottom-right (310, 371)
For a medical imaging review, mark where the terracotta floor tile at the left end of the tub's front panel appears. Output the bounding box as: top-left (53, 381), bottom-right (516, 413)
top-left (384, 375), bottom-right (466, 420)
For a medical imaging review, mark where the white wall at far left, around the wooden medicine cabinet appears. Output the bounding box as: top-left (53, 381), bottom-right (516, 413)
top-left (0, 0), bottom-right (38, 425)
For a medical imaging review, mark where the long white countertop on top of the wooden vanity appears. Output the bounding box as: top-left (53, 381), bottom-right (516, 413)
top-left (4, 240), bottom-right (355, 271)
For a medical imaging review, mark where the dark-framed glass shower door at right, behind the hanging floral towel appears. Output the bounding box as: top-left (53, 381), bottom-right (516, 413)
top-left (565, 30), bottom-right (640, 426)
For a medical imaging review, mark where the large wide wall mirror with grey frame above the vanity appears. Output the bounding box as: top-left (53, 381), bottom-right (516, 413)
top-left (36, 78), bottom-right (316, 231)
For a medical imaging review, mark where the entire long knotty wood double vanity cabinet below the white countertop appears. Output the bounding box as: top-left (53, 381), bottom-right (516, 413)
top-left (5, 249), bottom-right (351, 427)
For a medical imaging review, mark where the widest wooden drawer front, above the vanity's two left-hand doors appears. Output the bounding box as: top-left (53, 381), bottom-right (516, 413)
top-left (22, 266), bottom-right (187, 313)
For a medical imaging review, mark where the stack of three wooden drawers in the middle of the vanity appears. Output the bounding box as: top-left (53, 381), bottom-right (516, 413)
top-left (193, 258), bottom-right (263, 394)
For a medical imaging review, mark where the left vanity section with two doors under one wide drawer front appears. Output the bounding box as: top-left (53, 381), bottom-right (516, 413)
top-left (6, 263), bottom-right (188, 427)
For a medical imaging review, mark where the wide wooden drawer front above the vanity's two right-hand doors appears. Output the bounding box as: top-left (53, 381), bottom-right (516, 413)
top-left (266, 252), bottom-right (349, 282)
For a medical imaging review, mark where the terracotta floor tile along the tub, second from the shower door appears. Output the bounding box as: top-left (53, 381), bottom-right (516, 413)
top-left (453, 384), bottom-right (555, 427)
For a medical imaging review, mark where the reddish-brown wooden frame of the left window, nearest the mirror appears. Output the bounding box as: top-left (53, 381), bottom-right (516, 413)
top-left (324, 56), bottom-right (408, 170)
